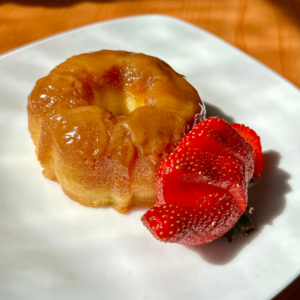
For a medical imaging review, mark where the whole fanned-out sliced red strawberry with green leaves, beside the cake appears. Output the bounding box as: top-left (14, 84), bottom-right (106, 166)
top-left (142, 117), bottom-right (263, 245)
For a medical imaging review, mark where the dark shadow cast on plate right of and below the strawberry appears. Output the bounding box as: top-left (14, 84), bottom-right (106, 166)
top-left (187, 150), bottom-right (291, 265)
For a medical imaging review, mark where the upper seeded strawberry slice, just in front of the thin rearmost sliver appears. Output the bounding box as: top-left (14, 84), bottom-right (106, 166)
top-left (177, 117), bottom-right (255, 181)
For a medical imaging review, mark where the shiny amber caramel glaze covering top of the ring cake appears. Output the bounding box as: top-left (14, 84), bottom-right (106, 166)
top-left (28, 50), bottom-right (204, 165)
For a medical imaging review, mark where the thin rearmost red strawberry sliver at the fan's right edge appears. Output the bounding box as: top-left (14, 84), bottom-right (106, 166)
top-left (231, 124), bottom-right (263, 179)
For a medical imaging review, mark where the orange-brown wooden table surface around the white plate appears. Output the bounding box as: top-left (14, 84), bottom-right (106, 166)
top-left (0, 0), bottom-right (300, 300)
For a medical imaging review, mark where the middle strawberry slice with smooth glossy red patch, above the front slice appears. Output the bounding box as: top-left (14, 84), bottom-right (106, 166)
top-left (156, 147), bottom-right (247, 214)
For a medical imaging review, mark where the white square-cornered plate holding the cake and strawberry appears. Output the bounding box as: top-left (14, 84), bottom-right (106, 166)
top-left (0, 16), bottom-right (300, 300)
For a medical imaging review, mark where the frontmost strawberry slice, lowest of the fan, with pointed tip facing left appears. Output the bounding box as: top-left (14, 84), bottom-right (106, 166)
top-left (142, 193), bottom-right (238, 245)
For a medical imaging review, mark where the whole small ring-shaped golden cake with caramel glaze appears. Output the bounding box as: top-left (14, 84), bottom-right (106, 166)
top-left (27, 50), bottom-right (205, 213)
